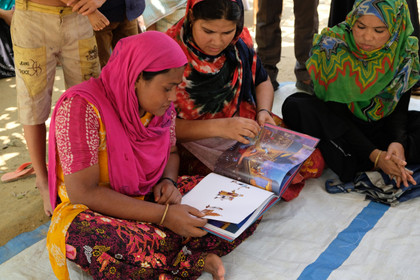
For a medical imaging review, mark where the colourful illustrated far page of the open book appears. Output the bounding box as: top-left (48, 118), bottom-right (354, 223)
top-left (215, 125), bottom-right (318, 194)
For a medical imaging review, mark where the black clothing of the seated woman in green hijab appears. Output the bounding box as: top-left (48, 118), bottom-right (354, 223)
top-left (282, 92), bottom-right (420, 182)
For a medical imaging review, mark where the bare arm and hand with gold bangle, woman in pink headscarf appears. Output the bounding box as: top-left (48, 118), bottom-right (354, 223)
top-left (64, 164), bottom-right (207, 237)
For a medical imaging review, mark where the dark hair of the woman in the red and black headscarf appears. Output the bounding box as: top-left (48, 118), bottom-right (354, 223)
top-left (192, 0), bottom-right (244, 37)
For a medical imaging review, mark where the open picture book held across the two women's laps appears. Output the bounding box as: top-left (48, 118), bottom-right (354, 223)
top-left (182, 124), bottom-right (319, 241)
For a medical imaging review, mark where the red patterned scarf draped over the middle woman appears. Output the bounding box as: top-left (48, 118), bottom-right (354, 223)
top-left (166, 0), bottom-right (257, 120)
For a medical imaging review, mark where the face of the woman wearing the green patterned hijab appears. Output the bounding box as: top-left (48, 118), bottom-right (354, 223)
top-left (352, 15), bottom-right (391, 51)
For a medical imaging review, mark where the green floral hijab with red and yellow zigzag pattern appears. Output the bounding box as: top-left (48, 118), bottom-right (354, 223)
top-left (306, 0), bottom-right (420, 121)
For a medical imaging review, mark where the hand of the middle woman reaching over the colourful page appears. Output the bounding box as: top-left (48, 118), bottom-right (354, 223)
top-left (219, 117), bottom-right (260, 144)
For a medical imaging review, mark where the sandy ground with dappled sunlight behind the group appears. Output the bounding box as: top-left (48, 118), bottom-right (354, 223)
top-left (0, 0), bottom-right (330, 246)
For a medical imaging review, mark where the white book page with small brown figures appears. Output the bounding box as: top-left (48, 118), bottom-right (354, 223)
top-left (182, 173), bottom-right (274, 224)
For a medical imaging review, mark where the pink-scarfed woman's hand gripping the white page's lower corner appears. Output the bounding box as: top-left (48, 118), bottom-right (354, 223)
top-left (163, 204), bottom-right (207, 237)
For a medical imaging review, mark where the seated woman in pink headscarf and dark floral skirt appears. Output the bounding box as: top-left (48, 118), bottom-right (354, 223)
top-left (47, 31), bottom-right (256, 279)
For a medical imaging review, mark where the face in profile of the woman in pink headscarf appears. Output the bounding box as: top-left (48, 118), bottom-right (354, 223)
top-left (136, 66), bottom-right (185, 116)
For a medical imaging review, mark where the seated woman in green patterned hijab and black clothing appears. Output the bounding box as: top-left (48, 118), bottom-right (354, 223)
top-left (283, 0), bottom-right (420, 186)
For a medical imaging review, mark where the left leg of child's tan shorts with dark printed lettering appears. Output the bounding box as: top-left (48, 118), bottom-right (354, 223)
top-left (11, 5), bottom-right (58, 125)
